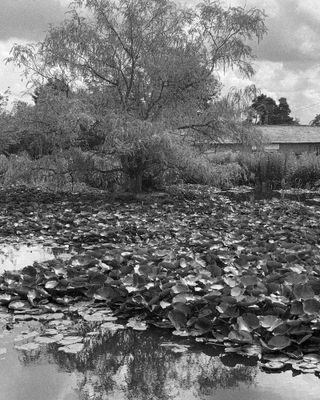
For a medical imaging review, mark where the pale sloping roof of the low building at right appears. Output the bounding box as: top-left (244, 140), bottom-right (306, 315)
top-left (257, 125), bottom-right (320, 143)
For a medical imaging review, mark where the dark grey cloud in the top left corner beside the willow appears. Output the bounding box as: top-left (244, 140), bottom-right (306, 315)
top-left (0, 0), bottom-right (67, 41)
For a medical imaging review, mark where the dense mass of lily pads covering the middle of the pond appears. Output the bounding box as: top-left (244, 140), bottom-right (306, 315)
top-left (0, 188), bottom-right (320, 373)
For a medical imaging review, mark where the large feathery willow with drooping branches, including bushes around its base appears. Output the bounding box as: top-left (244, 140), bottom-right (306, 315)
top-left (0, 0), bottom-right (266, 192)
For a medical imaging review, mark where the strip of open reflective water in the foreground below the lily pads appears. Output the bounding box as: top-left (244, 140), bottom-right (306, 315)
top-left (0, 322), bottom-right (320, 400)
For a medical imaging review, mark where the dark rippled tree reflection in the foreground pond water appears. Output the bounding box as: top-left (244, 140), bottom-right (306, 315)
top-left (16, 329), bottom-right (257, 400)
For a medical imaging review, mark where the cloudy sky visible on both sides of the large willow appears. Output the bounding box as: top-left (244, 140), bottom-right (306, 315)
top-left (0, 0), bottom-right (320, 124)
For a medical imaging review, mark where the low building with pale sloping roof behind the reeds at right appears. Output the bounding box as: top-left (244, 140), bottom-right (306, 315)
top-left (208, 125), bottom-right (320, 155)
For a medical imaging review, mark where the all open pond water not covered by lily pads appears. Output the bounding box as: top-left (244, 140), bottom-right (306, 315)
top-left (0, 206), bottom-right (320, 400)
